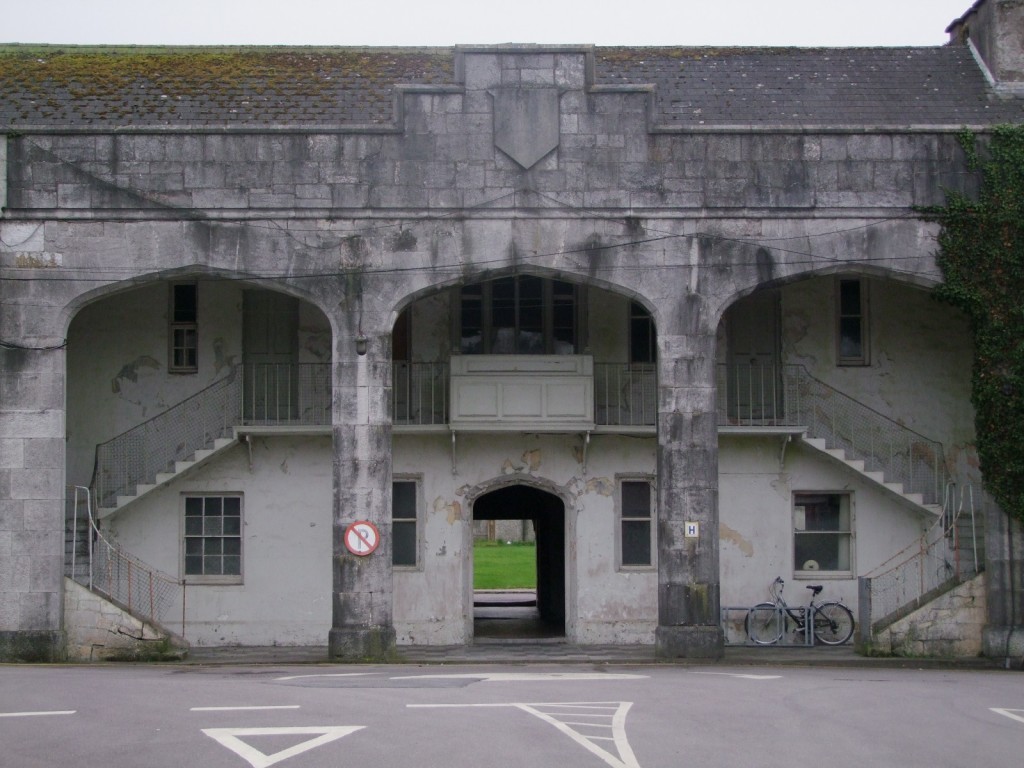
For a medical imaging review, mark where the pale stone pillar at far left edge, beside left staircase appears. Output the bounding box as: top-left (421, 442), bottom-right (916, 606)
top-left (0, 346), bottom-right (65, 662)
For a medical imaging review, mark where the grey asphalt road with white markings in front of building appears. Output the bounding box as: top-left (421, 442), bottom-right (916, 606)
top-left (0, 665), bottom-right (1024, 768)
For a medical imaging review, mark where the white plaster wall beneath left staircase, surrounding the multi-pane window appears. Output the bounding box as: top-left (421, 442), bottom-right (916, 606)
top-left (104, 435), bottom-right (333, 646)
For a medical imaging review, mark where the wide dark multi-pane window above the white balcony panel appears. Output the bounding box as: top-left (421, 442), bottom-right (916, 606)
top-left (455, 274), bottom-right (583, 354)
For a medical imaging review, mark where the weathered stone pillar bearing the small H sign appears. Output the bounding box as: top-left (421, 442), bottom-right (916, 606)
top-left (655, 331), bottom-right (725, 658)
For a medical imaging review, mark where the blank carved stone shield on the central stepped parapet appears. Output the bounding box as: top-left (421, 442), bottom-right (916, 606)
top-left (490, 88), bottom-right (559, 169)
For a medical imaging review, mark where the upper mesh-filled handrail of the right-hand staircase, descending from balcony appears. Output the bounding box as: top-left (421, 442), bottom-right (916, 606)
top-left (783, 365), bottom-right (950, 505)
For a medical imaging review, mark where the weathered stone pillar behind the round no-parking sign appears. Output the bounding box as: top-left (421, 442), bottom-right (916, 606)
top-left (328, 310), bottom-right (395, 660)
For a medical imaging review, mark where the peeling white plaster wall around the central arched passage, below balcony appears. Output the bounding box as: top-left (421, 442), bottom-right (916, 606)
top-left (394, 433), bottom-right (657, 644)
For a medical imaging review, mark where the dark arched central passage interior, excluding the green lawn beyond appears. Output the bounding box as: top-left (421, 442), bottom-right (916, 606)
top-left (473, 485), bottom-right (565, 639)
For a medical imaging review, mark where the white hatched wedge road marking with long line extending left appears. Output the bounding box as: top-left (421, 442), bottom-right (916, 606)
top-left (406, 701), bottom-right (640, 768)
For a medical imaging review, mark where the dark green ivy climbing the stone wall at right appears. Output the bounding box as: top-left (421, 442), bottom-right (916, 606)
top-left (925, 126), bottom-right (1024, 521)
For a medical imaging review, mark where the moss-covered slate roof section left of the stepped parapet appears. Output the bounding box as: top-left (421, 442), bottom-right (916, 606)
top-left (0, 46), bottom-right (453, 126)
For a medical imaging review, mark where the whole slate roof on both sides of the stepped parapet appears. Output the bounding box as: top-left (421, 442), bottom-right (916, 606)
top-left (0, 46), bottom-right (1024, 130)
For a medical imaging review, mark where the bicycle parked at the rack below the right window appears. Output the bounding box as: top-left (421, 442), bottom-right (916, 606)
top-left (744, 577), bottom-right (854, 645)
